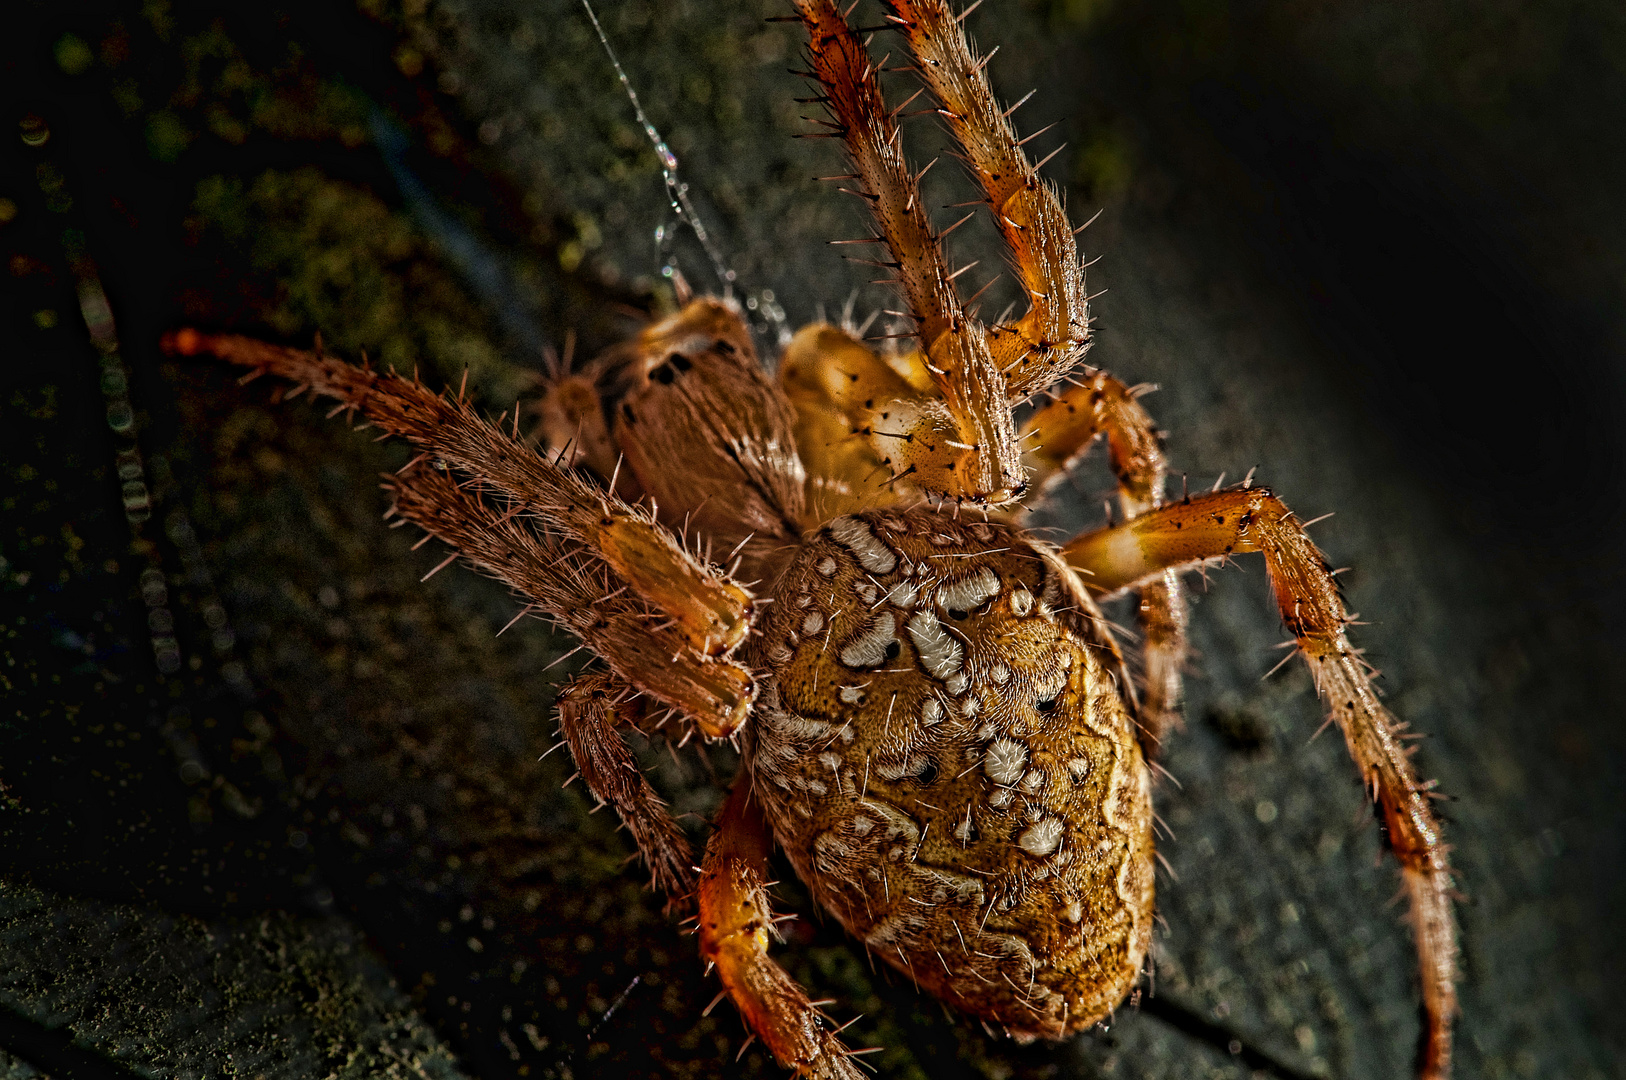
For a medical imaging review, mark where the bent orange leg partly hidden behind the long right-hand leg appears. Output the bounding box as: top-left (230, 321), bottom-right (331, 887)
top-left (1021, 371), bottom-right (1185, 751)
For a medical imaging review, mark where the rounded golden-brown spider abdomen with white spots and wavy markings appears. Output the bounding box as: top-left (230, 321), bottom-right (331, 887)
top-left (751, 509), bottom-right (1153, 1038)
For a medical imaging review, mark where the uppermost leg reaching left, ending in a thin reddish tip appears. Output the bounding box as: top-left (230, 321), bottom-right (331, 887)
top-left (166, 330), bottom-right (751, 666)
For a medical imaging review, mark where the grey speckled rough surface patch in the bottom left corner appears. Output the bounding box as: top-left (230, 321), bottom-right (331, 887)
top-left (0, 885), bottom-right (467, 1080)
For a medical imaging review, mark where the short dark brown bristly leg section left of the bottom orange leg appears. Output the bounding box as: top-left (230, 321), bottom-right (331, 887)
top-left (559, 672), bottom-right (694, 908)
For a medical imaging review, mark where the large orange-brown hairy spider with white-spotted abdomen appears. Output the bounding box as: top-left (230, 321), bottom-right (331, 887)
top-left (167, 0), bottom-right (1457, 1077)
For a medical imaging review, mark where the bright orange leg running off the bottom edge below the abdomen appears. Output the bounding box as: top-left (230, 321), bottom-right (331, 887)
top-left (699, 777), bottom-right (863, 1080)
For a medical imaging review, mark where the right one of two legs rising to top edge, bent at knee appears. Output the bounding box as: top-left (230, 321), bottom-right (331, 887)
top-left (888, 0), bottom-right (1089, 400)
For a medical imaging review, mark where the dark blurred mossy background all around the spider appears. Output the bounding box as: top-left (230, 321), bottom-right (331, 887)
top-left (0, 0), bottom-right (1626, 1078)
